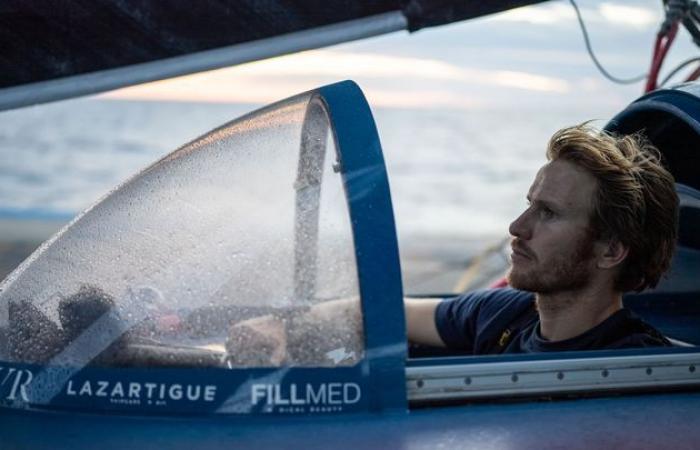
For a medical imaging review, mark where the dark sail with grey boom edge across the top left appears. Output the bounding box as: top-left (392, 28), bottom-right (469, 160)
top-left (0, 0), bottom-right (544, 109)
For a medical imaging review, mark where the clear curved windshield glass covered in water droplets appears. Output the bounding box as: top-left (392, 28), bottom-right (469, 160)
top-left (0, 94), bottom-right (364, 368)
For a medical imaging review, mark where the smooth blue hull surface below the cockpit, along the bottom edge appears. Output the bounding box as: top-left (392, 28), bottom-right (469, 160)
top-left (0, 393), bottom-right (700, 450)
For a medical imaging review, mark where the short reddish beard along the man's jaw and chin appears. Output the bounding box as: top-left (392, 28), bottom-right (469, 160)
top-left (506, 233), bottom-right (595, 294)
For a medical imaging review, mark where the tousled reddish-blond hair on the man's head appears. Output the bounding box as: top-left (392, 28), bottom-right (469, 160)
top-left (547, 123), bottom-right (678, 292)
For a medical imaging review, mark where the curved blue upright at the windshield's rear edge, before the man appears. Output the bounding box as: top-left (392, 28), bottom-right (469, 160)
top-left (318, 81), bottom-right (406, 410)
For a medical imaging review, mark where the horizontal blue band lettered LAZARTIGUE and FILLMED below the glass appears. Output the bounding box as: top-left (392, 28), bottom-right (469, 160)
top-left (0, 363), bottom-right (371, 416)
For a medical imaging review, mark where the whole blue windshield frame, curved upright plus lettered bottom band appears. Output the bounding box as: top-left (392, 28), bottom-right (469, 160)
top-left (0, 82), bottom-right (407, 418)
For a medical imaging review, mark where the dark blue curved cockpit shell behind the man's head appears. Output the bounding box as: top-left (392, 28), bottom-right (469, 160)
top-left (606, 84), bottom-right (700, 345)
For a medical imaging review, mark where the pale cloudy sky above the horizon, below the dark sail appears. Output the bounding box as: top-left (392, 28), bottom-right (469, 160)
top-left (103, 0), bottom-right (696, 110)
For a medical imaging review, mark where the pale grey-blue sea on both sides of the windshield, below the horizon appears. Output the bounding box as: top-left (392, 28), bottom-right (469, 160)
top-left (0, 97), bottom-right (624, 293)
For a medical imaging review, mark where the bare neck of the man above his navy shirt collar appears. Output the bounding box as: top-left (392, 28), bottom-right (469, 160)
top-left (535, 287), bottom-right (622, 341)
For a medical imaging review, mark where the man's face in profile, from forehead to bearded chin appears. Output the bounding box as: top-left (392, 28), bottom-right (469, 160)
top-left (507, 160), bottom-right (597, 294)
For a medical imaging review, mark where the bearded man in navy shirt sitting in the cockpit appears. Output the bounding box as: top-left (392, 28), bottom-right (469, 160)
top-left (405, 125), bottom-right (678, 354)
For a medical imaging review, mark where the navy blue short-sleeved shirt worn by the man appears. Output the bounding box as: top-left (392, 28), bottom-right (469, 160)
top-left (435, 288), bottom-right (671, 355)
